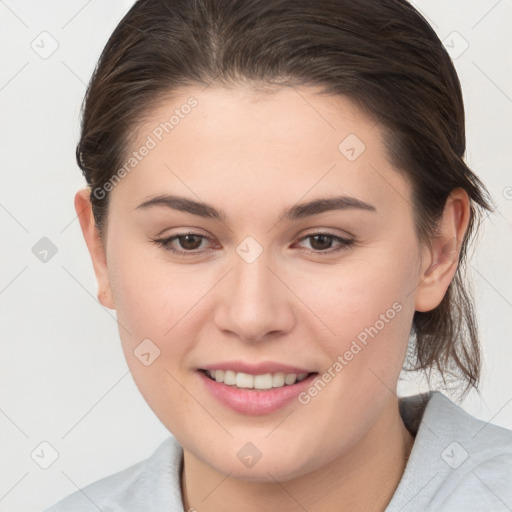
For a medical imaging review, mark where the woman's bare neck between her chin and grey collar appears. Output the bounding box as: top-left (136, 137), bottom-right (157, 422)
top-left (182, 398), bottom-right (414, 512)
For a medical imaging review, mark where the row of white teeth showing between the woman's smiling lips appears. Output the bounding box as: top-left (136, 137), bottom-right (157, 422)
top-left (200, 369), bottom-right (316, 391)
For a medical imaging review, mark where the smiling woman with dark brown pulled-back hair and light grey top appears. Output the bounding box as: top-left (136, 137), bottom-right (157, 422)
top-left (45, 0), bottom-right (512, 512)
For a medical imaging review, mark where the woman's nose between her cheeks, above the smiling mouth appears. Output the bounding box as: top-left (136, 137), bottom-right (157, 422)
top-left (215, 246), bottom-right (295, 342)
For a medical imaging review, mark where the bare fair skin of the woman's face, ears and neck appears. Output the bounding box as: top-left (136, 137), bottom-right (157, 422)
top-left (75, 86), bottom-right (469, 512)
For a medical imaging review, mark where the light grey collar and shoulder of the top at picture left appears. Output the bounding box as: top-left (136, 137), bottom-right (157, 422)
top-left (45, 437), bottom-right (183, 512)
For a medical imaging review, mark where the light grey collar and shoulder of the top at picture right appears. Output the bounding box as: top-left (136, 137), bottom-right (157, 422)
top-left (387, 392), bottom-right (512, 512)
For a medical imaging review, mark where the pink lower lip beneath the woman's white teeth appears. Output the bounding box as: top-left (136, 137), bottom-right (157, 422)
top-left (198, 371), bottom-right (318, 416)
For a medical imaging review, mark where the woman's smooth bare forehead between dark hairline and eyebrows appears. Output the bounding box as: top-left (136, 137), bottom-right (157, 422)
top-left (114, 86), bottom-right (409, 223)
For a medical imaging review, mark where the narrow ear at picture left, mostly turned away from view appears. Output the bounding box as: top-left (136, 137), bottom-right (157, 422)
top-left (75, 188), bottom-right (115, 309)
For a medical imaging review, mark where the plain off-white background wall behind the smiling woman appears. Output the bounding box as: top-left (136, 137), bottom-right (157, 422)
top-left (0, 0), bottom-right (512, 512)
